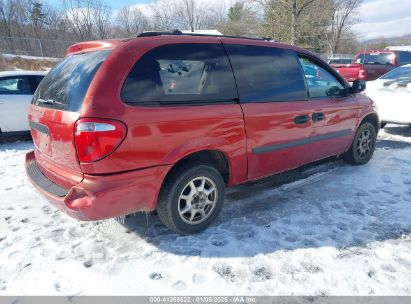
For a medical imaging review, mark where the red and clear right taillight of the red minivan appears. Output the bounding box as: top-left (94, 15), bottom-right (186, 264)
top-left (74, 118), bottom-right (127, 163)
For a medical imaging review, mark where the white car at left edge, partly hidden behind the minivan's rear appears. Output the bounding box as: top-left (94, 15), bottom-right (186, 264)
top-left (0, 71), bottom-right (47, 137)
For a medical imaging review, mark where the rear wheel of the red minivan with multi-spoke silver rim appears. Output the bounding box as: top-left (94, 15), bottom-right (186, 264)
top-left (157, 162), bottom-right (225, 235)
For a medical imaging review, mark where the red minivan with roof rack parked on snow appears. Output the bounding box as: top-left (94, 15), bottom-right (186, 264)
top-left (26, 32), bottom-right (380, 234)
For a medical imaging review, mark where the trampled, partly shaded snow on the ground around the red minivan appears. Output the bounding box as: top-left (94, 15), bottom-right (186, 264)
top-left (0, 127), bottom-right (411, 295)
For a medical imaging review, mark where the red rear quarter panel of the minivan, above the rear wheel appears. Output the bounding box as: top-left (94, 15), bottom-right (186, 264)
top-left (81, 103), bottom-right (246, 182)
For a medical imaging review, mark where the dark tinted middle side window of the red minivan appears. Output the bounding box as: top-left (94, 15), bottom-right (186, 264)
top-left (225, 44), bottom-right (307, 102)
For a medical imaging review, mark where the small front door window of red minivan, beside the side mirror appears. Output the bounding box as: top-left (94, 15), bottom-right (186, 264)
top-left (300, 57), bottom-right (347, 98)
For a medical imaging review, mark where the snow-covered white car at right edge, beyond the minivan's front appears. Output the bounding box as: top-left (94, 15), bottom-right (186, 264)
top-left (365, 64), bottom-right (411, 127)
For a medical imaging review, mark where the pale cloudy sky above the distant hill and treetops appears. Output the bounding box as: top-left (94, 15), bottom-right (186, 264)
top-left (48, 0), bottom-right (411, 40)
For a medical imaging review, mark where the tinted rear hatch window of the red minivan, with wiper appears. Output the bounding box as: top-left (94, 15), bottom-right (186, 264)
top-left (32, 51), bottom-right (110, 112)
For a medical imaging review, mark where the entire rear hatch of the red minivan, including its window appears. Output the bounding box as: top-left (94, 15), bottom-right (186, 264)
top-left (29, 50), bottom-right (110, 183)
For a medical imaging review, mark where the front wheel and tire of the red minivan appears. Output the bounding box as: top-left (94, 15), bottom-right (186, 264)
top-left (343, 122), bottom-right (377, 165)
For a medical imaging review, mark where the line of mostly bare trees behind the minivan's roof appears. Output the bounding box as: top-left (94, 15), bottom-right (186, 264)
top-left (0, 0), bottom-right (363, 55)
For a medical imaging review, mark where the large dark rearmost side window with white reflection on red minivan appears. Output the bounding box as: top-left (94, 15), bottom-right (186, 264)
top-left (121, 44), bottom-right (237, 104)
